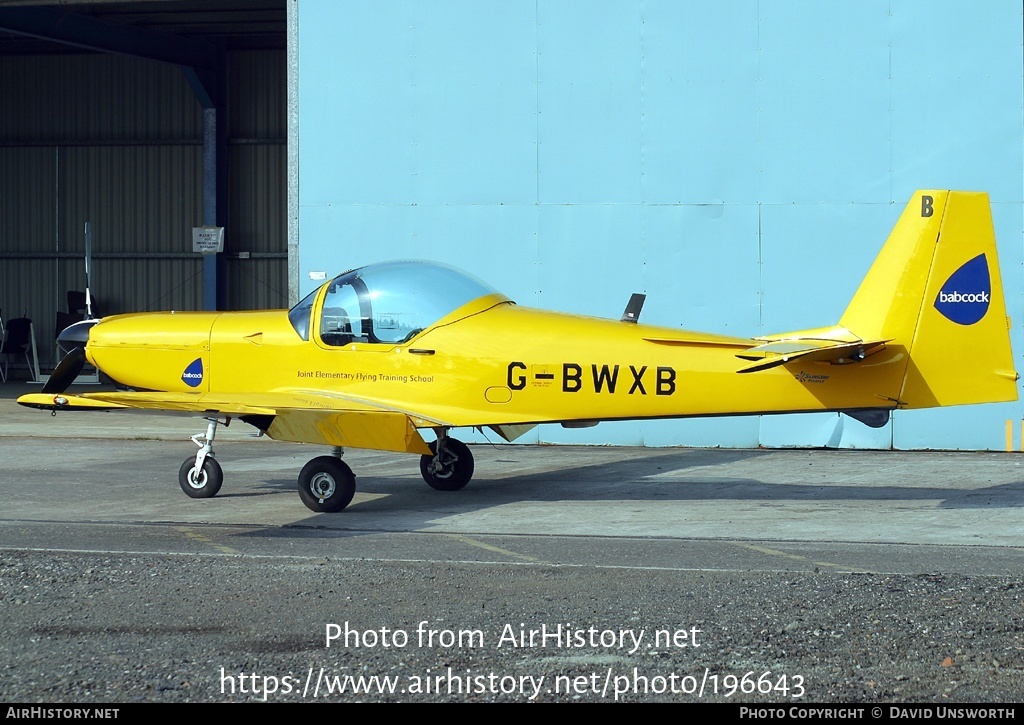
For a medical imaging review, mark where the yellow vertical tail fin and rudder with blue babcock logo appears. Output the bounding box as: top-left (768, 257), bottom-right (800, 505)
top-left (840, 190), bottom-right (1018, 408)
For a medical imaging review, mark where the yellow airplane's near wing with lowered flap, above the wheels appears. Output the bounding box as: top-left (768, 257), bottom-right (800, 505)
top-left (18, 391), bottom-right (436, 455)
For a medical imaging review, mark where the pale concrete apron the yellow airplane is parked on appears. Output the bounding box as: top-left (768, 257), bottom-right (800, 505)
top-left (0, 386), bottom-right (1024, 572)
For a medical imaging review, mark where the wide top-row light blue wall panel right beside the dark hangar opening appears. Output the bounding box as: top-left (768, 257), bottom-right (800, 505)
top-left (298, 0), bottom-right (537, 204)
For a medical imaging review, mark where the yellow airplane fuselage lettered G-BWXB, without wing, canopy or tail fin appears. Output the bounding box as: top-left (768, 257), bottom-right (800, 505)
top-left (86, 295), bottom-right (906, 426)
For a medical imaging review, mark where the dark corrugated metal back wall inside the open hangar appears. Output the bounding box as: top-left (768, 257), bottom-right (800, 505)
top-left (0, 50), bottom-right (287, 366)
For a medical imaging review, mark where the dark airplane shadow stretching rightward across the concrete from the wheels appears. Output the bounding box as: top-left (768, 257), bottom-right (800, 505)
top-left (232, 449), bottom-right (1024, 536)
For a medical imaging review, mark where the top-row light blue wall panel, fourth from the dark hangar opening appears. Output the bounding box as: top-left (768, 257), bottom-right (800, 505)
top-left (757, 0), bottom-right (889, 203)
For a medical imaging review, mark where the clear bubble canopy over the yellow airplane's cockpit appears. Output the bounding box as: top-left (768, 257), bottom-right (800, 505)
top-left (288, 261), bottom-right (498, 345)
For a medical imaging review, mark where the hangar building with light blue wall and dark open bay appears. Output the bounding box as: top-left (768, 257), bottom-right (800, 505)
top-left (0, 0), bottom-right (1024, 450)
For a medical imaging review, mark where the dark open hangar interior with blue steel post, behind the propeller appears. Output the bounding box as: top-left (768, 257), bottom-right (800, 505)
top-left (0, 0), bottom-right (288, 368)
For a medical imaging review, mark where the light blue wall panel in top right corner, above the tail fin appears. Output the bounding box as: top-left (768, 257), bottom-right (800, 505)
top-left (891, 0), bottom-right (1024, 202)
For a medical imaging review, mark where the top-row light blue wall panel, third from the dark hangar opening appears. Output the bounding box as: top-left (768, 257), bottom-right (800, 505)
top-left (640, 0), bottom-right (760, 204)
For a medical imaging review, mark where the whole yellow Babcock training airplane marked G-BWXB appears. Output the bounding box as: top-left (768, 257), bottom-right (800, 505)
top-left (18, 190), bottom-right (1018, 512)
